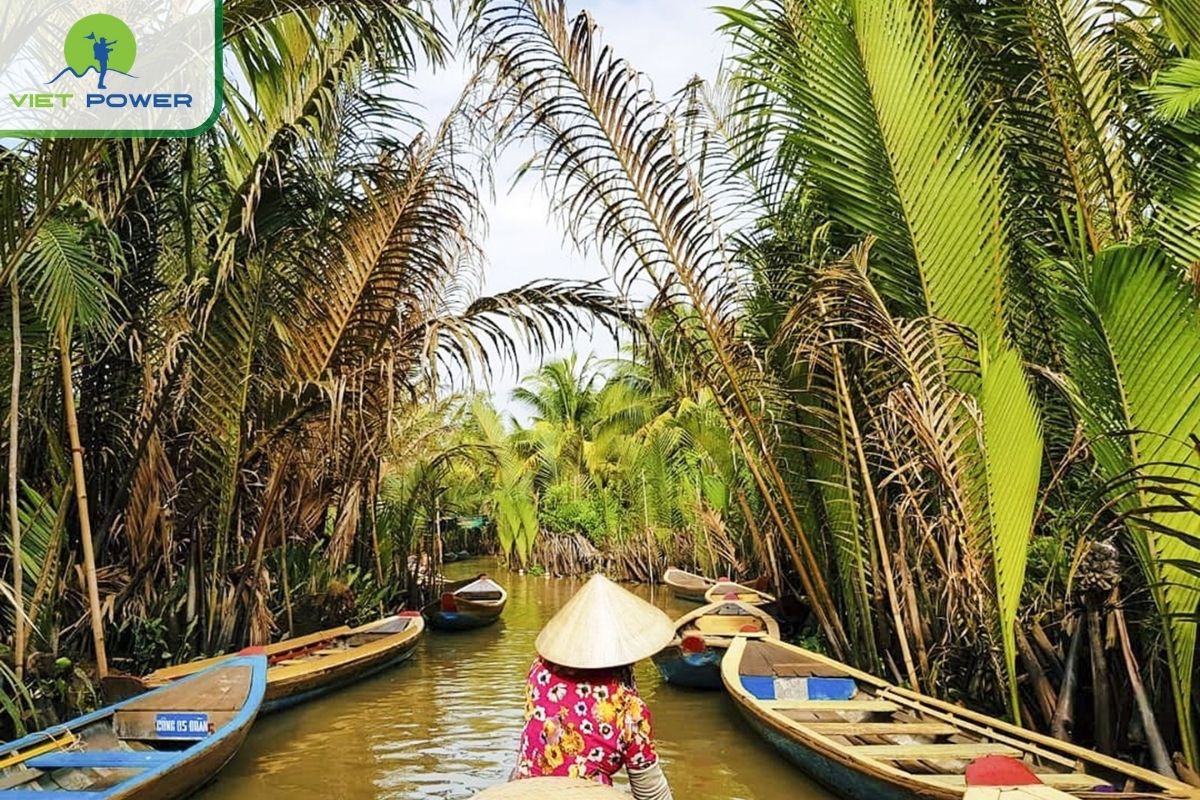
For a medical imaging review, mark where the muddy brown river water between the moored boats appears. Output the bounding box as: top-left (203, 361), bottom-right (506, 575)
top-left (200, 561), bottom-right (832, 800)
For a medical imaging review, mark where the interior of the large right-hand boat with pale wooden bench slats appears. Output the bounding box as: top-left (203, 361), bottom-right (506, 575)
top-left (738, 639), bottom-right (1178, 800)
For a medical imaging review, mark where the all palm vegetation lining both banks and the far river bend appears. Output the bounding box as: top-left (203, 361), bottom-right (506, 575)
top-left (0, 0), bottom-right (1200, 771)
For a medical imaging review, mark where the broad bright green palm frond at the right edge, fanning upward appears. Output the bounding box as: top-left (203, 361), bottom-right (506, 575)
top-left (1063, 246), bottom-right (1200, 751)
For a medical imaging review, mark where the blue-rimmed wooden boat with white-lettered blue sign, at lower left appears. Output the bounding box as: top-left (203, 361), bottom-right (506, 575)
top-left (0, 655), bottom-right (266, 800)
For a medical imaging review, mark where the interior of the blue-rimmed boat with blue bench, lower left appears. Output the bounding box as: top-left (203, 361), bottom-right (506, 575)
top-left (0, 663), bottom-right (253, 800)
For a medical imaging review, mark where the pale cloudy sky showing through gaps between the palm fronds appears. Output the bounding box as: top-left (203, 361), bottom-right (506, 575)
top-left (415, 0), bottom-right (725, 420)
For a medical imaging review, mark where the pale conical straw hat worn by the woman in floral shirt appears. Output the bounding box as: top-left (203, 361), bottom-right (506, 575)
top-left (538, 575), bottom-right (674, 669)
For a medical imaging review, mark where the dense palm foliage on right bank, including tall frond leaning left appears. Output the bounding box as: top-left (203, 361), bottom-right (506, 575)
top-left (475, 0), bottom-right (1200, 770)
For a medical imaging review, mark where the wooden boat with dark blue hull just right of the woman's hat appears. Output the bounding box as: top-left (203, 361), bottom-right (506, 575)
top-left (654, 600), bottom-right (779, 688)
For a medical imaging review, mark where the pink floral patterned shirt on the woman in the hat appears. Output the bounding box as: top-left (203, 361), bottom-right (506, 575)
top-left (514, 658), bottom-right (659, 786)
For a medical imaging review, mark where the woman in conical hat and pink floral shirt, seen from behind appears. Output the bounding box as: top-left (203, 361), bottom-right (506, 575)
top-left (512, 575), bottom-right (674, 800)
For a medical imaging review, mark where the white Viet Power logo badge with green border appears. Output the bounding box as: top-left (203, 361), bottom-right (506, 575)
top-left (0, 0), bottom-right (221, 137)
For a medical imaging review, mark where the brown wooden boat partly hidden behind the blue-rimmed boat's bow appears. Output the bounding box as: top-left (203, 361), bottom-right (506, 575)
top-left (133, 612), bottom-right (425, 714)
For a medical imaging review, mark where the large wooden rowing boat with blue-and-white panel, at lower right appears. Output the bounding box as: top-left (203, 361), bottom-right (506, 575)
top-left (721, 638), bottom-right (1200, 800)
